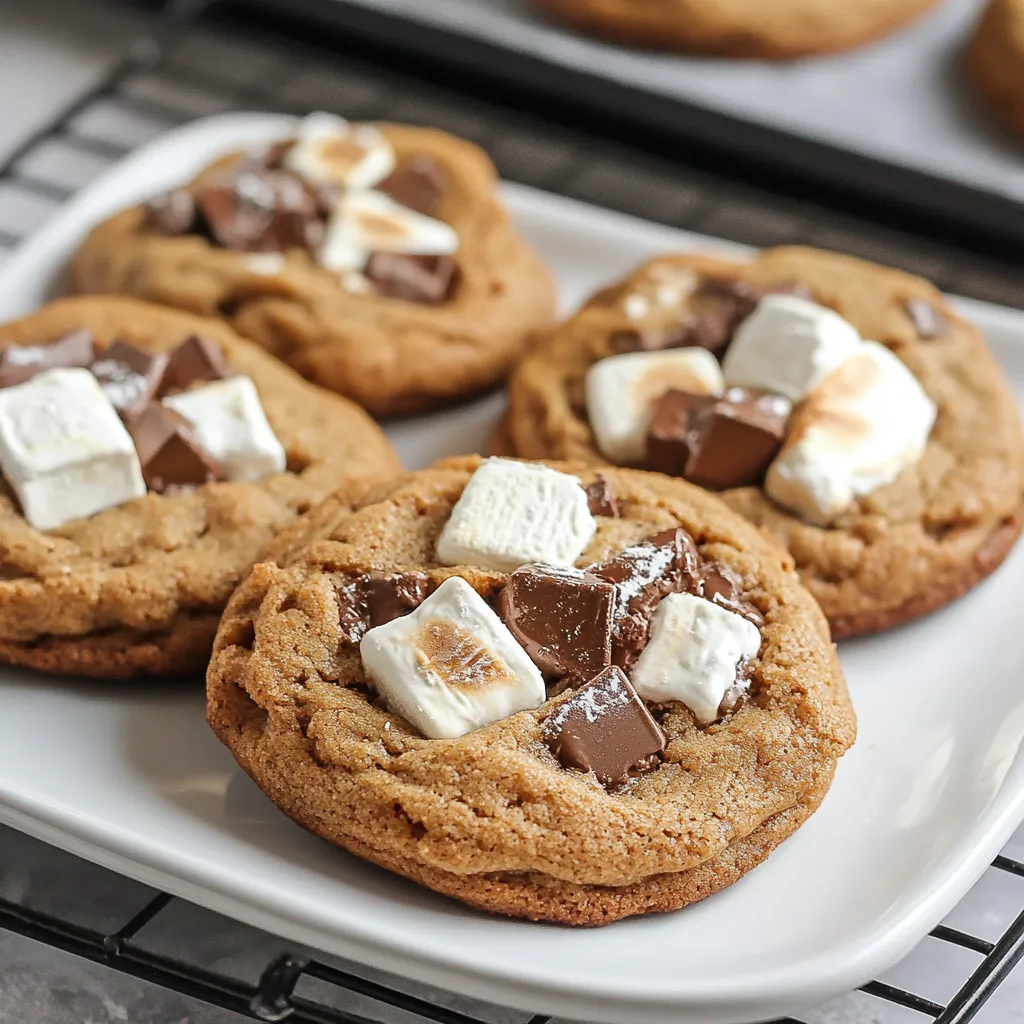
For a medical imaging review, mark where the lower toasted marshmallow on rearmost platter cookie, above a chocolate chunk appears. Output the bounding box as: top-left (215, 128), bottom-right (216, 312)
top-left (319, 191), bottom-right (459, 271)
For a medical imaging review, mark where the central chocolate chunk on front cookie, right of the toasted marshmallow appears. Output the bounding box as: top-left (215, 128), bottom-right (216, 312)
top-left (498, 565), bottom-right (615, 679)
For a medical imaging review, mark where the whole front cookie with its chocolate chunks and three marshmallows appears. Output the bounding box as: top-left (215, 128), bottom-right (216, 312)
top-left (207, 457), bottom-right (855, 925)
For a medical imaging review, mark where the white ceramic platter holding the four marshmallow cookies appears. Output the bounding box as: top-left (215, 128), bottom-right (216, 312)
top-left (0, 115), bottom-right (1024, 1024)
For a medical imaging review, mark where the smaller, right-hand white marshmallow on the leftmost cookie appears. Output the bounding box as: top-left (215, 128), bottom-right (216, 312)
top-left (164, 376), bottom-right (287, 480)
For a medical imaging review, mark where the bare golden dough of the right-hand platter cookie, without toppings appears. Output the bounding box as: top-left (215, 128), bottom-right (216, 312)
top-left (501, 243), bottom-right (1024, 637)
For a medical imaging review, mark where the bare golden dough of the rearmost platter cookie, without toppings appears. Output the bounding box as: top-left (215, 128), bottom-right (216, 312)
top-left (71, 125), bottom-right (555, 416)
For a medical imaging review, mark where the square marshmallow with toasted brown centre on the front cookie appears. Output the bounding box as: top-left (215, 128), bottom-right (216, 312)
top-left (359, 577), bottom-right (547, 739)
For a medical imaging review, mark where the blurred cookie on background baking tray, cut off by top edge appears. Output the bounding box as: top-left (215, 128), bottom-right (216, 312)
top-left (537, 0), bottom-right (937, 59)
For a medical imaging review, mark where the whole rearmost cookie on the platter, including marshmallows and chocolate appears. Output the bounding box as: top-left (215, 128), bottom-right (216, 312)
top-left (71, 115), bottom-right (555, 416)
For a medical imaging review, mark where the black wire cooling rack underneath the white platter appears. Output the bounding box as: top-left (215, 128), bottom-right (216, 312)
top-left (0, 0), bottom-right (1024, 1024)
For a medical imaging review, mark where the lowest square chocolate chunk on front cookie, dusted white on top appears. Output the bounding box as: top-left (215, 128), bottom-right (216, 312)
top-left (542, 667), bottom-right (667, 788)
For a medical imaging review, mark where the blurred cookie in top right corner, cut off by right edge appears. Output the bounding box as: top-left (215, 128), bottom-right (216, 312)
top-left (967, 0), bottom-right (1024, 135)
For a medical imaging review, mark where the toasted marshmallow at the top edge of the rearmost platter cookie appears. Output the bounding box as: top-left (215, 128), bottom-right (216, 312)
top-left (284, 114), bottom-right (395, 188)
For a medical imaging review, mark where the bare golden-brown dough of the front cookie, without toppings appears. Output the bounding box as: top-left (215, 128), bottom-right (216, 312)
top-left (207, 458), bottom-right (855, 925)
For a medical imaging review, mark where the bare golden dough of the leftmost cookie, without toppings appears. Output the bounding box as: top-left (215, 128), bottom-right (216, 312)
top-left (0, 298), bottom-right (400, 678)
